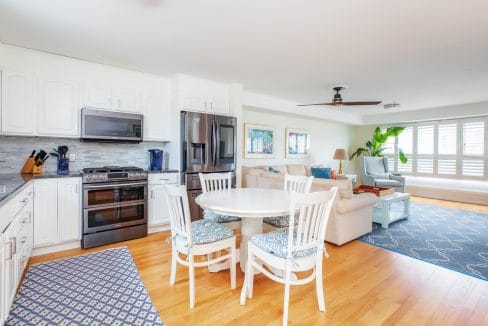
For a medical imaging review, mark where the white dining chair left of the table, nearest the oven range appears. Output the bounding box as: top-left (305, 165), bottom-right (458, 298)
top-left (163, 184), bottom-right (237, 308)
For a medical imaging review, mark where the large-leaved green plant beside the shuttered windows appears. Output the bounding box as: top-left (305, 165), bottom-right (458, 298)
top-left (349, 127), bottom-right (408, 164)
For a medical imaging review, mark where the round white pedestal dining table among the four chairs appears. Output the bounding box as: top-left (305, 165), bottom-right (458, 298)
top-left (195, 188), bottom-right (291, 272)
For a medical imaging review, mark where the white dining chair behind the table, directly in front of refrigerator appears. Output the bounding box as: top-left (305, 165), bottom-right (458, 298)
top-left (198, 172), bottom-right (241, 229)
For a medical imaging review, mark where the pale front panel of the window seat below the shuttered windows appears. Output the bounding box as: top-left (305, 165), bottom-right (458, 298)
top-left (405, 186), bottom-right (488, 205)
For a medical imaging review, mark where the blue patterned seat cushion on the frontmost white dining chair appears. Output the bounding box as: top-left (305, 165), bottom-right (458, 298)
top-left (251, 230), bottom-right (317, 258)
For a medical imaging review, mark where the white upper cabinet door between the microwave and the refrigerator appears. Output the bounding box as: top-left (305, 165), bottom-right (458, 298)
top-left (143, 93), bottom-right (172, 141)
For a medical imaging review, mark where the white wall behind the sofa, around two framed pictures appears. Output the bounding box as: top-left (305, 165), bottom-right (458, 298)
top-left (241, 106), bottom-right (355, 173)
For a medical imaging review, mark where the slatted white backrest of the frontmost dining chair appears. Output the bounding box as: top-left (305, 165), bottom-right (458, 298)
top-left (288, 187), bottom-right (337, 258)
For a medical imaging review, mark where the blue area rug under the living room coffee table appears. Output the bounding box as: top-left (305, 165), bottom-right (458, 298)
top-left (359, 203), bottom-right (488, 280)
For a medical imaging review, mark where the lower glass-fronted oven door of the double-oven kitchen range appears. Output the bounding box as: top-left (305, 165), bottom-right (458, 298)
top-left (83, 201), bottom-right (147, 234)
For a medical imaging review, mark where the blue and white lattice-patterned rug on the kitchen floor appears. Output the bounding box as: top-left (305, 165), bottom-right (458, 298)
top-left (5, 247), bottom-right (162, 325)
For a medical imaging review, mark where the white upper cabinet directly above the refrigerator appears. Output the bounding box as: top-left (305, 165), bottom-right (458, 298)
top-left (175, 75), bottom-right (230, 115)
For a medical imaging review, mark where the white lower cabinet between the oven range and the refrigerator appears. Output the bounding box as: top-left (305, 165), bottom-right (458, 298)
top-left (148, 173), bottom-right (179, 227)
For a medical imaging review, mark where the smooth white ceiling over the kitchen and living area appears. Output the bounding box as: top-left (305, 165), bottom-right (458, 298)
top-left (0, 0), bottom-right (488, 115)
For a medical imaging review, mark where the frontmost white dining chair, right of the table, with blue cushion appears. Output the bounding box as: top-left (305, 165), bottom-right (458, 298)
top-left (240, 187), bottom-right (337, 325)
